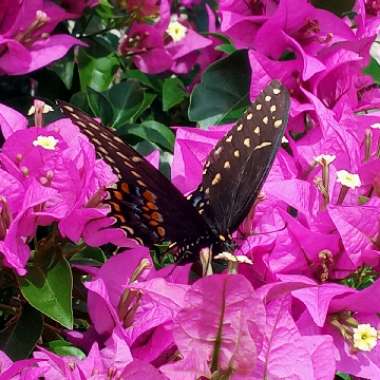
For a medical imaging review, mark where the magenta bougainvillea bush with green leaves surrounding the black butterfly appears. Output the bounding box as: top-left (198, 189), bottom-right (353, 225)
top-left (0, 0), bottom-right (380, 380)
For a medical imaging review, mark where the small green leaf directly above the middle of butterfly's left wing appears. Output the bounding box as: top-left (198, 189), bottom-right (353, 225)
top-left (125, 120), bottom-right (174, 151)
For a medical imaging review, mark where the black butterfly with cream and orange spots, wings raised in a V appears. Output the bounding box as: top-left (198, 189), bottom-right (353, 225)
top-left (58, 81), bottom-right (289, 263)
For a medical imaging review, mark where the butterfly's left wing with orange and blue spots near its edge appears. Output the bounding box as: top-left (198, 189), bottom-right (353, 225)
top-left (58, 101), bottom-right (209, 255)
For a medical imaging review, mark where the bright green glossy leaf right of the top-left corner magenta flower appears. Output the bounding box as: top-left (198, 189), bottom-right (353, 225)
top-left (77, 49), bottom-right (118, 92)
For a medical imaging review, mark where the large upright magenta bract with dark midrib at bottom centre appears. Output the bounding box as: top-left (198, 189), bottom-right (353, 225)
top-left (161, 275), bottom-right (265, 380)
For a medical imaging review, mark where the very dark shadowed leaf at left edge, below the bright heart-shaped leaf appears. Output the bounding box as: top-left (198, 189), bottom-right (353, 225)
top-left (0, 304), bottom-right (43, 360)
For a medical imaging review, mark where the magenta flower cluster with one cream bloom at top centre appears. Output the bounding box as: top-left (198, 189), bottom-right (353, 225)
top-left (120, 0), bottom-right (220, 74)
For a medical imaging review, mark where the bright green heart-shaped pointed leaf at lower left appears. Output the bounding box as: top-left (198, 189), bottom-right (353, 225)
top-left (19, 252), bottom-right (73, 329)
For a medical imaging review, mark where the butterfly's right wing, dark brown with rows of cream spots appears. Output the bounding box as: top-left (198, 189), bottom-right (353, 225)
top-left (191, 81), bottom-right (289, 234)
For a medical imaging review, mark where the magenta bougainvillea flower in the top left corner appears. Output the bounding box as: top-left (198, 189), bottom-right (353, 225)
top-left (0, 0), bottom-right (83, 75)
